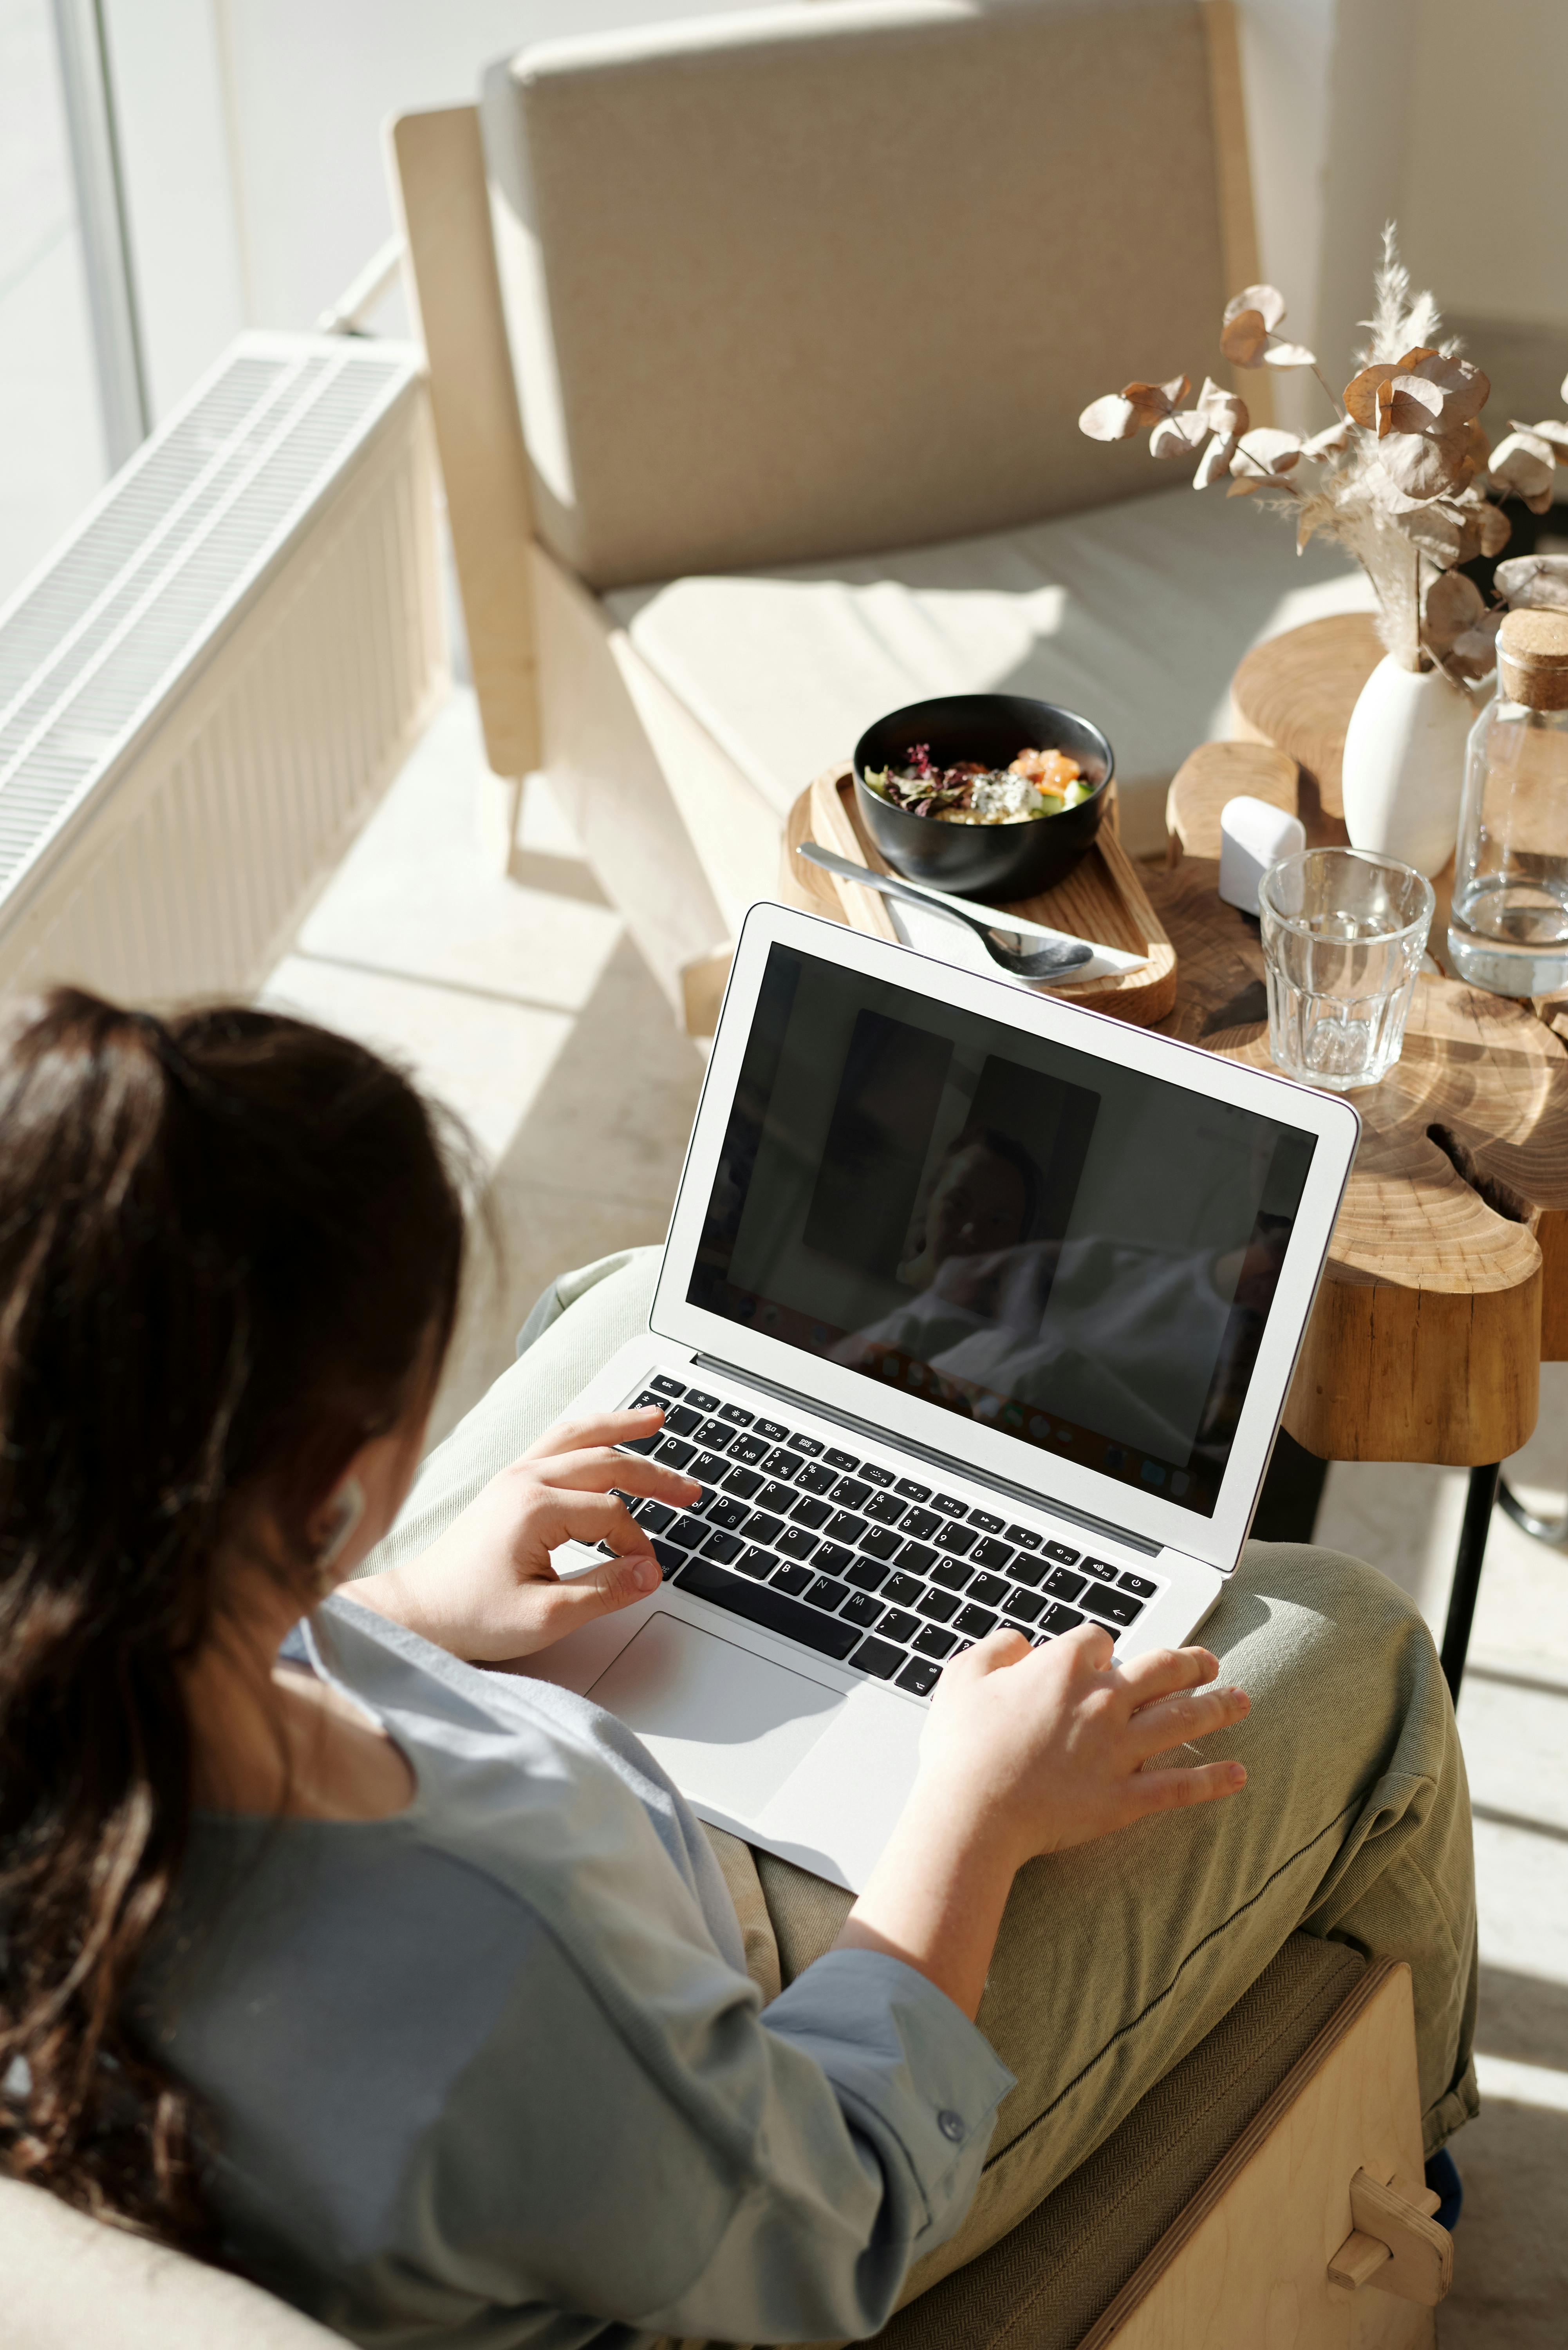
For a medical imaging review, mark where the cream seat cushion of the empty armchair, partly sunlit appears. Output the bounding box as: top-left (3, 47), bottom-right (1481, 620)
top-left (604, 486), bottom-right (1373, 853)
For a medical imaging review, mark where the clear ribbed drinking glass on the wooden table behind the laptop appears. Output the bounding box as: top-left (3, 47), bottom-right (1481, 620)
top-left (1258, 848), bottom-right (1436, 1093)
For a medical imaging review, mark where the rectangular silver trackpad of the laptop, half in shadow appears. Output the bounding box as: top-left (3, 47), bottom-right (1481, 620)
top-left (588, 1612), bottom-right (844, 1817)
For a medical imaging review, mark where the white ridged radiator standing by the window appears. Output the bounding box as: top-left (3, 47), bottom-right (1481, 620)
top-left (0, 334), bottom-right (449, 1003)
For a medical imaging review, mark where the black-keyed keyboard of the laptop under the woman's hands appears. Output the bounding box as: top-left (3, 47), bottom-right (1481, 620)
top-left (621, 1372), bottom-right (1159, 1697)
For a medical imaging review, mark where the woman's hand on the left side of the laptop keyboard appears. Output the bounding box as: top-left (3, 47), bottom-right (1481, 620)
top-left (343, 1405), bottom-right (703, 1664)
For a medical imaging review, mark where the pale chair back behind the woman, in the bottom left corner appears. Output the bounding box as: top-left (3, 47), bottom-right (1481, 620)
top-left (0, 2178), bottom-right (341, 2350)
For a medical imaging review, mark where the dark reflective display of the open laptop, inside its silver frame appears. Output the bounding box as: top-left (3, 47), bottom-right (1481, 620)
top-left (686, 945), bottom-right (1314, 1516)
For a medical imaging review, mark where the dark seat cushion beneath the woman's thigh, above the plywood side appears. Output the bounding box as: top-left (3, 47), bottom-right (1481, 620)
top-left (874, 1934), bottom-right (1366, 2350)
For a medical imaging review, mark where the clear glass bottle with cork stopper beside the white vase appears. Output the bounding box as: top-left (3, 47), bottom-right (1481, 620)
top-left (1448, 611), bottom-right (1568, 996)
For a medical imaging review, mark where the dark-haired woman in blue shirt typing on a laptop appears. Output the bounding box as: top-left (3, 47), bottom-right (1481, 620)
top-left (0, 989), bottom-right (1474, 2345)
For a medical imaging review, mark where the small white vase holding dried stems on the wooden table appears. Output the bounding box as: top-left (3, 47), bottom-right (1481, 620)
top-left (1342, 653), bottom-right (1476, 879)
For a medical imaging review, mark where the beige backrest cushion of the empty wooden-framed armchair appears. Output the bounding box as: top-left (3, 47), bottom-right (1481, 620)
top-left (482, 0), bottom-right (1230, 588)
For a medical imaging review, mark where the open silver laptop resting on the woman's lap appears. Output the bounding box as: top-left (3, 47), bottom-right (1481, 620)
top-left (527, 905), bottom-right (1361, 1889)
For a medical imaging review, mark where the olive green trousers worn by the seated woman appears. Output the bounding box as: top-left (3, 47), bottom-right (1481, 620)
top-left (369, 1250), bottom-right (1476, 2331)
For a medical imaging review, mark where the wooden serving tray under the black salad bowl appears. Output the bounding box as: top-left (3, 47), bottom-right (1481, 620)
top-left (780, 766), bottom-right (1175, 1027)
